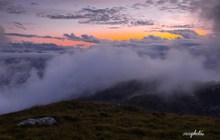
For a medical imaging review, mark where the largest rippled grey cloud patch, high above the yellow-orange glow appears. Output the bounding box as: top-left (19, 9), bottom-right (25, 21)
top-left (43, 7), bottom-right (153, 26)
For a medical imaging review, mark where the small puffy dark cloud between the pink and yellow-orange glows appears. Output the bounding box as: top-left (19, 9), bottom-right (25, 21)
top-left (64, 33), bottom-right (100, 43)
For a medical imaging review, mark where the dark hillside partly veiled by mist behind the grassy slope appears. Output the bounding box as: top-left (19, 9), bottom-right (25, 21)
top-left (85, 81), bottom-right (220, 117)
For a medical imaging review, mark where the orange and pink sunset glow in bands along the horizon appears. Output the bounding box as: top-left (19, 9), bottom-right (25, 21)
top-left (8, 29), bottom-right (209, 46)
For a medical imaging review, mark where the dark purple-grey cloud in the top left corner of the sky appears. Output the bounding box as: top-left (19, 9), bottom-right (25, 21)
top-left (0, 0), bottom-right (26, 14)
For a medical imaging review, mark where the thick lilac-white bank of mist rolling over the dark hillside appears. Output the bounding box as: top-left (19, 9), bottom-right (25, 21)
top-left (0, 36), bottom-right (220, 114)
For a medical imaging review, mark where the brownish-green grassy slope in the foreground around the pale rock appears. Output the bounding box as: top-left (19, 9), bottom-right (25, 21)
top-left (0, 101), bottom-right (220, 140)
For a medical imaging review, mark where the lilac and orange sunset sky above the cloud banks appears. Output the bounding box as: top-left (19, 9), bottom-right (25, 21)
top-left (0, 0), bottom-right (212, 46)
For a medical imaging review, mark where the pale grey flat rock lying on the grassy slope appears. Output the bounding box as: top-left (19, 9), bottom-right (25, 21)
top-left (17, 117), bottom-right (57, 126)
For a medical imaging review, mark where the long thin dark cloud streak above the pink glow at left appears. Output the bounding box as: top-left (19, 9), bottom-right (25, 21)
top-left (5, 33), bottom-right (64, 40)
